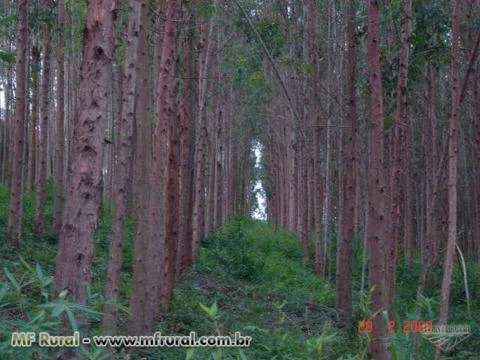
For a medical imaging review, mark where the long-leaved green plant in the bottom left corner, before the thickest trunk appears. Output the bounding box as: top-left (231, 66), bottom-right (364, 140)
top-left (0, 257), bottom-right (100, 359)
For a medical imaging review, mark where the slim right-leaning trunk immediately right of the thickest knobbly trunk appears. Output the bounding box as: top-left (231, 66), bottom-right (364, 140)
top-left (103, 0), bottom-right (142, 333)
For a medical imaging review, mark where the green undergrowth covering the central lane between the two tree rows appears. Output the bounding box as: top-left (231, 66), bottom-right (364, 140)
top-left (146, 217), bottom-right (349, 359)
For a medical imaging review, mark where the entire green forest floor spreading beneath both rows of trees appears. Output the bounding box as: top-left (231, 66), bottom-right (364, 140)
top-left (0, 186), bottom-right (480, 360)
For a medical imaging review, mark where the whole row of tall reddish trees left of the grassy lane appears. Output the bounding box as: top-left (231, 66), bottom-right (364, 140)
top-left (1, 0), bottom-right (258, 340)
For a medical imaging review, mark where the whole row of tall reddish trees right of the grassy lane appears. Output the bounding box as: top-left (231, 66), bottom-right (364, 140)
top-left (260, 0), bottom-right (480, 359)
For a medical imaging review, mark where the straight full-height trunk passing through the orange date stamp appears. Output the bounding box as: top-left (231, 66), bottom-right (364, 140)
top-left (368, 0), bottom-right (390, 360)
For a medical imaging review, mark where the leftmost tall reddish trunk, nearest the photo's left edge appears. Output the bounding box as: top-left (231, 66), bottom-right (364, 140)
top-left (7, 0), bottom-right (28, 246)
